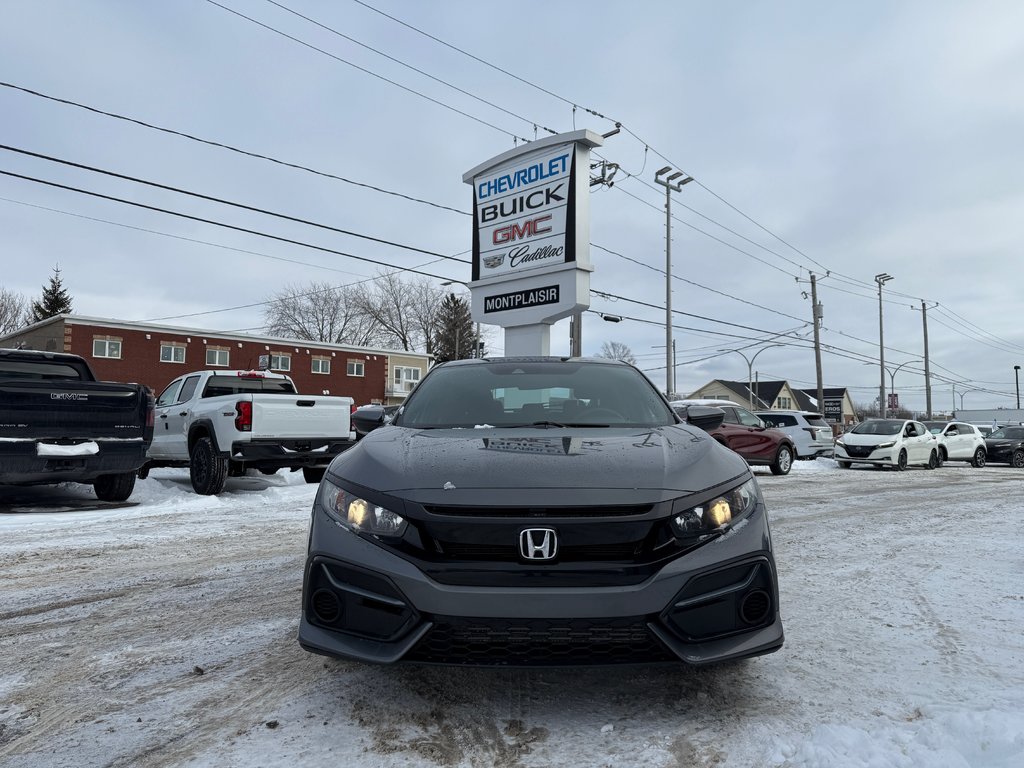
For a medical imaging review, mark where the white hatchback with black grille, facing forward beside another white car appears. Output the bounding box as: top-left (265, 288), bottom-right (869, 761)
top-left (835, 419), bottom-right (939, 469)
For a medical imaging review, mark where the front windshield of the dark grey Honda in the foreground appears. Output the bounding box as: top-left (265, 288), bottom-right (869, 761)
top-left (396, 359), bottom-right (676, 428)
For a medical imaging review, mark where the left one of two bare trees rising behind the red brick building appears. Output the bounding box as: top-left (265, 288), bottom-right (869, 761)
top-left (263, 283), bottom-right (379, 346)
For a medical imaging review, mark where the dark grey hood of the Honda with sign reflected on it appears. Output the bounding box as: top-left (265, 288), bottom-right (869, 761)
top-left (330, 424), bottom-right (750, 504)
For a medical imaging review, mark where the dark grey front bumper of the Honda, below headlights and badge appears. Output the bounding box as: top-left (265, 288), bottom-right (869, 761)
top-left (298, 505), bottom-right (783, 667)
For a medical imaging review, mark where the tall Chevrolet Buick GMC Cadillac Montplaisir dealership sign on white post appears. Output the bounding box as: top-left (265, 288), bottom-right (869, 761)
top-left (463, 130), bottom-right (603, 354)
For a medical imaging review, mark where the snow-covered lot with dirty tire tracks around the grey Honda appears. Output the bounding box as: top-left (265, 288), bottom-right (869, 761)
top-left (0, 459), bottom-right (1024, 768)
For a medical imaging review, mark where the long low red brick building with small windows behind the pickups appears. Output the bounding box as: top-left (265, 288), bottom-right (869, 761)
top-left (0, 314), bottom-right (431, 404)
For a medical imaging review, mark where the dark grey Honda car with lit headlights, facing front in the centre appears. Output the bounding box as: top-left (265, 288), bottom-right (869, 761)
top-left (299, 357), bottom-right (783, 667)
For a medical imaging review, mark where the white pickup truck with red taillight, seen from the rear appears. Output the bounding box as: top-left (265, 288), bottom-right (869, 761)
top-left (145, 371), bottom-right (355, 495)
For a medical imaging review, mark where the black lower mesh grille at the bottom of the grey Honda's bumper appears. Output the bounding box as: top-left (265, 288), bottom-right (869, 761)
top-left (406, 616), bottom-right (679, 667)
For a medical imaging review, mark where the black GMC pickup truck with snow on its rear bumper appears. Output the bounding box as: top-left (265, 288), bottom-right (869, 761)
top-left (0, 349), bottom-right (154, 501)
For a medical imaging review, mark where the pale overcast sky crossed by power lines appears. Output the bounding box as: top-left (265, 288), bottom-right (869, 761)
top-left (0, 0), bottom-right (1024, 410)
